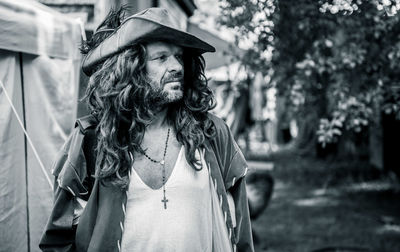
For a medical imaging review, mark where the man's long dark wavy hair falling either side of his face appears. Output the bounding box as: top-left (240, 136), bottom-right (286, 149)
top-left (84, 8), bottom-right (216, 190)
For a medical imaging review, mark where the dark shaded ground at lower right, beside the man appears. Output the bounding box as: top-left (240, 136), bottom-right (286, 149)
top-left (253, 179), bottom-right (400, 252)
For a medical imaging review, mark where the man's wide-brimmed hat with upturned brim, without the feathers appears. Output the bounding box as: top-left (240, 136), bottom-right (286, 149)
top-left (82, 8), bottom-right (215, 76)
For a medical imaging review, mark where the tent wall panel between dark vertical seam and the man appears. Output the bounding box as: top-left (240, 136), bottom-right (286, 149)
top-left (22, 54), bottom-right (79, 251)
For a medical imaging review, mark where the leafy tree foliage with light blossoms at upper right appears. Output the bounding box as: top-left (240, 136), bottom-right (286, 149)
top-left (220, 0), bottom-right (400, 148)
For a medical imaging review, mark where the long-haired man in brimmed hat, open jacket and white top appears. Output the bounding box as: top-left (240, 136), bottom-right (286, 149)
top-left (39, 8), bottom-right (254, 251)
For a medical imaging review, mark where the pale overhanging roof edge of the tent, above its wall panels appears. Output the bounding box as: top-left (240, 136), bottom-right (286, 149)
top-left (0, 0), bottom-right (80, 59)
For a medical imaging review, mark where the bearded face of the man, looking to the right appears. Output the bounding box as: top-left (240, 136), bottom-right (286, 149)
top-left (146, 42), bottom-right (184, 104)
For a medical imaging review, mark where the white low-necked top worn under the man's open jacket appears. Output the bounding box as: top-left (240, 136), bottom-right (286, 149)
top-left (121, 146), bottom-right (213, 252)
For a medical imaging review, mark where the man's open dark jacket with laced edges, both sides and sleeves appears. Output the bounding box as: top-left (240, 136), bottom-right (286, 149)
top-left (39, 114), bottom-right (254, 252)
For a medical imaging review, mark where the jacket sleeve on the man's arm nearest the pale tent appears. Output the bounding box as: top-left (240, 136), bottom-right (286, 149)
top-left (39, 128), bottom-right (89, 252)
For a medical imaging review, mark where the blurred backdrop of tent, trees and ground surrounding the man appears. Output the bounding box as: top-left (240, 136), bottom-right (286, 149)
top-left (0, 0), bottom-right (400, 252)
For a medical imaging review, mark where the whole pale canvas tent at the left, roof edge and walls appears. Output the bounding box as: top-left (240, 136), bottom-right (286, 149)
top-left (0, 0), bottom-right (81, 252)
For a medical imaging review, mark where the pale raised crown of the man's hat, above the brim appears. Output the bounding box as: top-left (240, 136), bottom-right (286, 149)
top-left (128, 7), bottom-right (180, 30)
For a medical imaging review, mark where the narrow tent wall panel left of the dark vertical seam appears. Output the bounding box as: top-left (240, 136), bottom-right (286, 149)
top-left (0, 51), bottom-right (27, 252)
